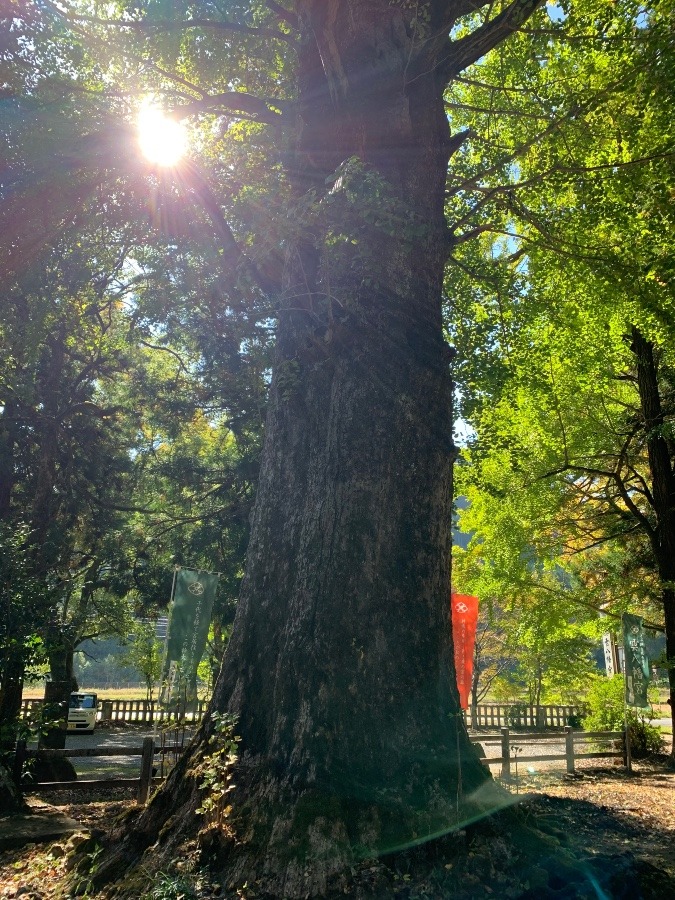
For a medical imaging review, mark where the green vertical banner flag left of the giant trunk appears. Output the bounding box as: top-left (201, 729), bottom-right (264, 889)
top-left (159, 569), bottom-right (219, 706)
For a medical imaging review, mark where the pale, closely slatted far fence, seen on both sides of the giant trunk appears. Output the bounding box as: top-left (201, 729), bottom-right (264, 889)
top-left (21, 699), bottom-right (585, 730)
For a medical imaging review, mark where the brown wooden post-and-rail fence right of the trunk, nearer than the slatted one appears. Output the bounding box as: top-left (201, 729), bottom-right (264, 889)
top-left (472, 725), bottom-right (630, 778)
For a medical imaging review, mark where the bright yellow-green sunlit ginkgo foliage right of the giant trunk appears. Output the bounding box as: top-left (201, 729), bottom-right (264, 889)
top-left (450, 2), bottom-right (675, 744)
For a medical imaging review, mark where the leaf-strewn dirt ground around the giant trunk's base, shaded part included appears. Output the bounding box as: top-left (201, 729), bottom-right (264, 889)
top-left (0, 756), bottom-right (675, 900)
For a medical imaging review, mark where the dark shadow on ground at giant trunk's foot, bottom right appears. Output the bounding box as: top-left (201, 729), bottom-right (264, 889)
top-left (351, 794), bottom-right (675, 900)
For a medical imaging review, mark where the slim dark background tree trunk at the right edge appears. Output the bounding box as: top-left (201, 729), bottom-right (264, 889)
top-left (631, 327), bottom-right (675, 755)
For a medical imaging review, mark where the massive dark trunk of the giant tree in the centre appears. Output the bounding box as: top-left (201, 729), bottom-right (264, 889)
top-left (99, 0), bottom-right (540, 896)
